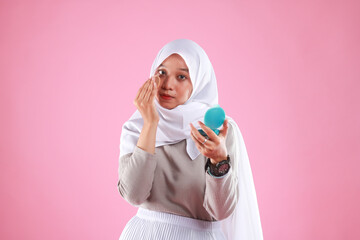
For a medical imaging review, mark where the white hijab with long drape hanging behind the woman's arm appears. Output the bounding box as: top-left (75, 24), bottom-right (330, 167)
top-left (120, 39), bottom-right (263, 240)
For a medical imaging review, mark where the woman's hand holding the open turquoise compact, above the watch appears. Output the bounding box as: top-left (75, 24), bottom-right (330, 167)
top-left (190, 119), bottom-right (228, 164)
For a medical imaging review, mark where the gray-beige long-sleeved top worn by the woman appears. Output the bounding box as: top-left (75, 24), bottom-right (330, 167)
top-left (118, 124), bottom-right (239, 221)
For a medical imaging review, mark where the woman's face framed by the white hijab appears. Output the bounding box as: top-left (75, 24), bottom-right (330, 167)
top-left (155, 53), bottom-right (193, 109)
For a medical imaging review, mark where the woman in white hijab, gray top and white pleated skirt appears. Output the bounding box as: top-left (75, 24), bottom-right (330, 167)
top-left (118, 39), bottom-right (262, 240)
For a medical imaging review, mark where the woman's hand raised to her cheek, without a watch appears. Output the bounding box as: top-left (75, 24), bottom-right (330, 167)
top-left (134, 76), bottom-right (159, 124)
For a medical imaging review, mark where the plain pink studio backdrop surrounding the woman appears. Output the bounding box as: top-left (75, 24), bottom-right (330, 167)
top-left (0, 0), bottom-right (360, 240)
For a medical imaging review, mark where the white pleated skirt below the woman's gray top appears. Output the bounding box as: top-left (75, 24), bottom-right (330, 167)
top-left (119, 208), bottom-right (226, 240)
